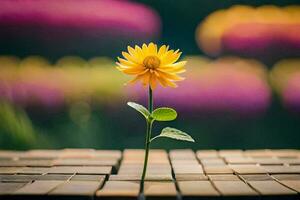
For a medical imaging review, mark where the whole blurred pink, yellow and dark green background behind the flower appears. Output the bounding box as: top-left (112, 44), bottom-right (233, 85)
top-left (0, 0), bottom-right (300, 149)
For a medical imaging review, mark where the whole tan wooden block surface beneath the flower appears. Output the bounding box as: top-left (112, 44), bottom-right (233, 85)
top-left (0, 149), bottom-right (300, 200)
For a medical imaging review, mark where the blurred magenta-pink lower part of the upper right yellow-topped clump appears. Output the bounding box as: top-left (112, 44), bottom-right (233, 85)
top-left (222, 23), bottom-right (300, 62)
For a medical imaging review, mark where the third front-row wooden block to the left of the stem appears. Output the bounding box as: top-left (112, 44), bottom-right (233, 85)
top-left (14, 181), bottom-right (64, 195)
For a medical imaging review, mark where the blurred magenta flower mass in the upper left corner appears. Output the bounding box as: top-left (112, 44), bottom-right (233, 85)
top-left (0, 0), bottom-right (160, 56)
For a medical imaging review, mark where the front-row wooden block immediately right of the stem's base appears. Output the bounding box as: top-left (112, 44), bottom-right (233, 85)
top-left (144, 181), bottom-right (177, 199)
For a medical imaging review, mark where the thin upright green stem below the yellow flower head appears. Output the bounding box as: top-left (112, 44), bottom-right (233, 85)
top-left (140, 86), bottom-right (153, 192)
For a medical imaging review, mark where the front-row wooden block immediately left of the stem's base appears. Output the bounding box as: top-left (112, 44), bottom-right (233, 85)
top-left (96, 181), bottom-right (140, 199)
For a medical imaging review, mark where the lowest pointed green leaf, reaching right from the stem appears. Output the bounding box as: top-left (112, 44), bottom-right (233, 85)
top-left (151, 127), bottom-right (195, 142)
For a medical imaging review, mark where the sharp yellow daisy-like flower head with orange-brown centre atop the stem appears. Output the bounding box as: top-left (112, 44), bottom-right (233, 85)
top-left (117, 43), bottom-right (186, 89)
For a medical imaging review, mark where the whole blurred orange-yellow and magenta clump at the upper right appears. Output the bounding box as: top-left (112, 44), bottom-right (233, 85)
top-left (196, 5), bottom-right (300, 63)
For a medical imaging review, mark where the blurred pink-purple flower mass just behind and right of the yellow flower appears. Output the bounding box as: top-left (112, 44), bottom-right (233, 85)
top-left (128, 61), bottom-right (271, 115)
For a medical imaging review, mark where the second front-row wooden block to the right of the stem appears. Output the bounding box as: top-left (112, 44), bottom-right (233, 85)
top-left (178, 181), bottom-right (220, 199)
